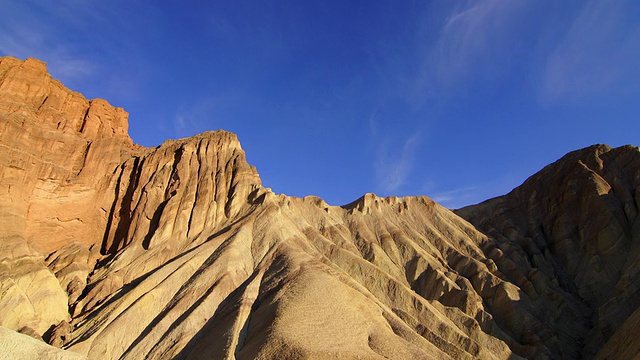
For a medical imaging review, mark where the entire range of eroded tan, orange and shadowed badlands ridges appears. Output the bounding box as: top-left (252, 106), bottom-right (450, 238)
top-left (0, 57), bottom-right (640, 359)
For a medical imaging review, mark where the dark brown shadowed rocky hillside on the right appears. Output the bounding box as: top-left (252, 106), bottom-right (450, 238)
top-left (458, 145), bottom-right (640, 358)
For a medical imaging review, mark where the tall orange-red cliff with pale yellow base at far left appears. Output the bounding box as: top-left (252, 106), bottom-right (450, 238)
top-left (0, 57), bottom-right (138, 335)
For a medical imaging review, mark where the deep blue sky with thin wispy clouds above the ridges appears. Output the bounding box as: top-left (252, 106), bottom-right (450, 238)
top-left (0, 0), bottom-right (640, 208)
